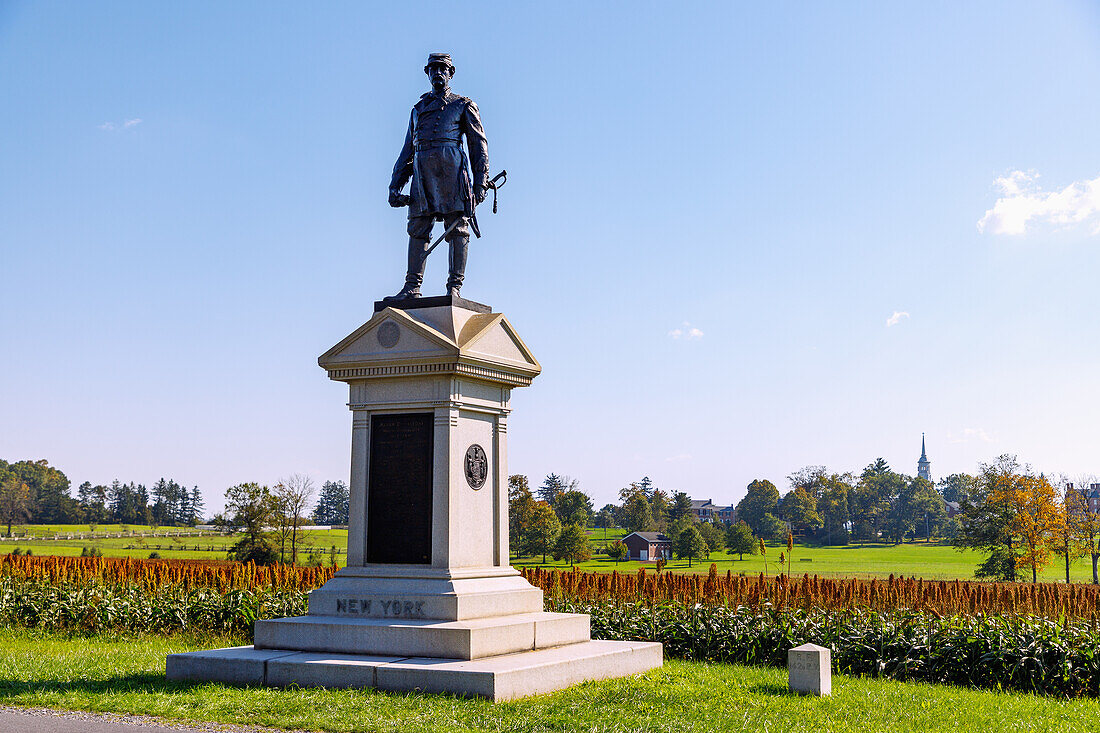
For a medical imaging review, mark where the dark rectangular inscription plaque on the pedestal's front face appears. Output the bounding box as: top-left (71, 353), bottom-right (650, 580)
top-left (366, 413), bottom-right (433, 565)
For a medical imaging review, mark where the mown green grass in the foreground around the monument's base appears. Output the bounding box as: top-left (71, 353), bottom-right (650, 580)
top-left (0, 628), bottom-right (1100, 733)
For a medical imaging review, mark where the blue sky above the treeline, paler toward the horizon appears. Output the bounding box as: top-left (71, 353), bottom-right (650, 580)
top-left (0, 1), bottom-right (1100, 508)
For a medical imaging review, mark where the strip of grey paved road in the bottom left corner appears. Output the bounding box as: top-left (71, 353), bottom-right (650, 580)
top-left (0, 708), bottom-right (305, 733)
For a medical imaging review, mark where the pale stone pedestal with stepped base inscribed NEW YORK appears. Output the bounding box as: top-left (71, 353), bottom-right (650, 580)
top-left (167, 296), bottom-right (662, 700)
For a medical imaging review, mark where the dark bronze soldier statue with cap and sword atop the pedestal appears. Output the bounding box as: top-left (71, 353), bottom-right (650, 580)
top-left (386, 54), bottom-right (493, 300)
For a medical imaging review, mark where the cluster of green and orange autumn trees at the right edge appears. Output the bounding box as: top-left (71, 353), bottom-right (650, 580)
top-left (954, 455), bottom-right (1100, 583)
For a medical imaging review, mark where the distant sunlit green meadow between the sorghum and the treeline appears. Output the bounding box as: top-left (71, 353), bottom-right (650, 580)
top-left (0, 525), bottom-right (1092, 582)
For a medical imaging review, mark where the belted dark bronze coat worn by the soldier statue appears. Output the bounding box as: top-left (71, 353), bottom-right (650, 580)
top-left (389, 91), bottom-right (488, 220)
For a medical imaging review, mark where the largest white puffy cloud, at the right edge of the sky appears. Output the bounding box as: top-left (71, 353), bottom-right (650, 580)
top-left (978, 171), bottom-right (1100, 234)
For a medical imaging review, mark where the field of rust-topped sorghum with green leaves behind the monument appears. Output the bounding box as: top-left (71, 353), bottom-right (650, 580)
top-left (0, 557), bottom-right (1100, 697)
